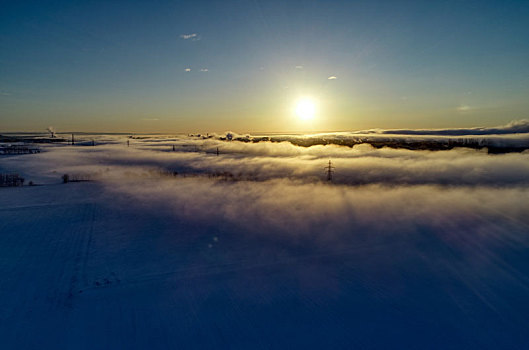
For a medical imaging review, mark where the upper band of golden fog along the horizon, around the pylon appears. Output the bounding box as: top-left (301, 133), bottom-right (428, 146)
top-left (5, 136), bottom-right (529, 186)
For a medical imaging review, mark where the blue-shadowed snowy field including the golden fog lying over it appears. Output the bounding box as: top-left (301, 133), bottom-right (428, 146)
top-left (0, 135), bottom-right (529, 349)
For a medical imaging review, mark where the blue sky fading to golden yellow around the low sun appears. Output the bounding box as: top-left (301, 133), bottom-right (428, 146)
top-left (0, 1), bottom-right (529, 132)
